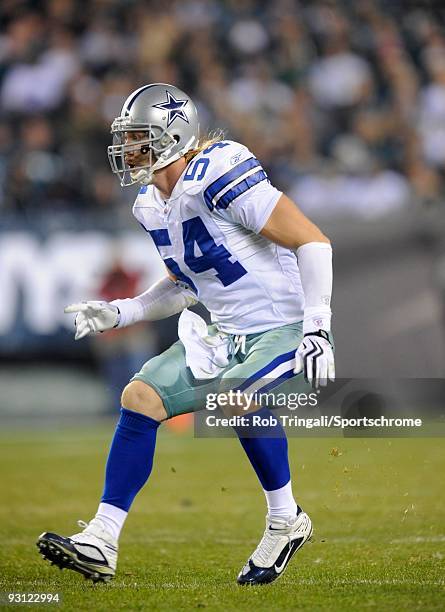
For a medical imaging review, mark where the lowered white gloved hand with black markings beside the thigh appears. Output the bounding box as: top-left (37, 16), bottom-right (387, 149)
top-left (294, 330), bottom-right (335, 389)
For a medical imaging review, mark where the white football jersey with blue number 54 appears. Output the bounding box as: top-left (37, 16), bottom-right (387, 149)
top-left (133, 140), bottom-right (304, 334)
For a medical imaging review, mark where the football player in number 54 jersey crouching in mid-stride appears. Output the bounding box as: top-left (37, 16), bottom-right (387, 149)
top-left (37, 83), bottom-right (335, 585)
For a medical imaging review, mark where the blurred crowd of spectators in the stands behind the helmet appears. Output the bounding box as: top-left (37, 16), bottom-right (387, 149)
top-left (0, 0), bottom-right (445, 218)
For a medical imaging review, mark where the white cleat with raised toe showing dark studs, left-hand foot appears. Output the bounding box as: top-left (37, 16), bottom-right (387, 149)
top-left (37, 518), bottom-right (118, 582)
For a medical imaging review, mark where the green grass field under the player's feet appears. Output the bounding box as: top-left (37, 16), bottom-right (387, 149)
top-left (0, 424), bottom-right (445, 612)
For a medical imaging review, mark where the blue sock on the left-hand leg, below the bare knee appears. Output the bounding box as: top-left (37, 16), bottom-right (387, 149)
top-left (101, 408), bottom-right (160, 512)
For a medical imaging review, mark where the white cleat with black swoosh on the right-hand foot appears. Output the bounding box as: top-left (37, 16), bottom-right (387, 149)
top-left (237, 511), bottom-right (312, 584)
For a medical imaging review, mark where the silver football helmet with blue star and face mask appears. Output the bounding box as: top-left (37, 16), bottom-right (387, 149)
top-left (108, 83), bottom-right (199, 187)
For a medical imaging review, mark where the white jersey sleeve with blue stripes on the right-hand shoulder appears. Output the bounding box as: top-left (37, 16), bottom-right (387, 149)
top-left (194, 141), bottom-right (281, 234)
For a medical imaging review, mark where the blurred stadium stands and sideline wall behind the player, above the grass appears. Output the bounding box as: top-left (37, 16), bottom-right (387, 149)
top-left (0, 0), bottom-right (445, 416)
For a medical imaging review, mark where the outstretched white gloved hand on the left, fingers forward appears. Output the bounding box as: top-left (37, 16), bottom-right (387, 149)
top-left (64, 302), bottom-right (120, 340)
